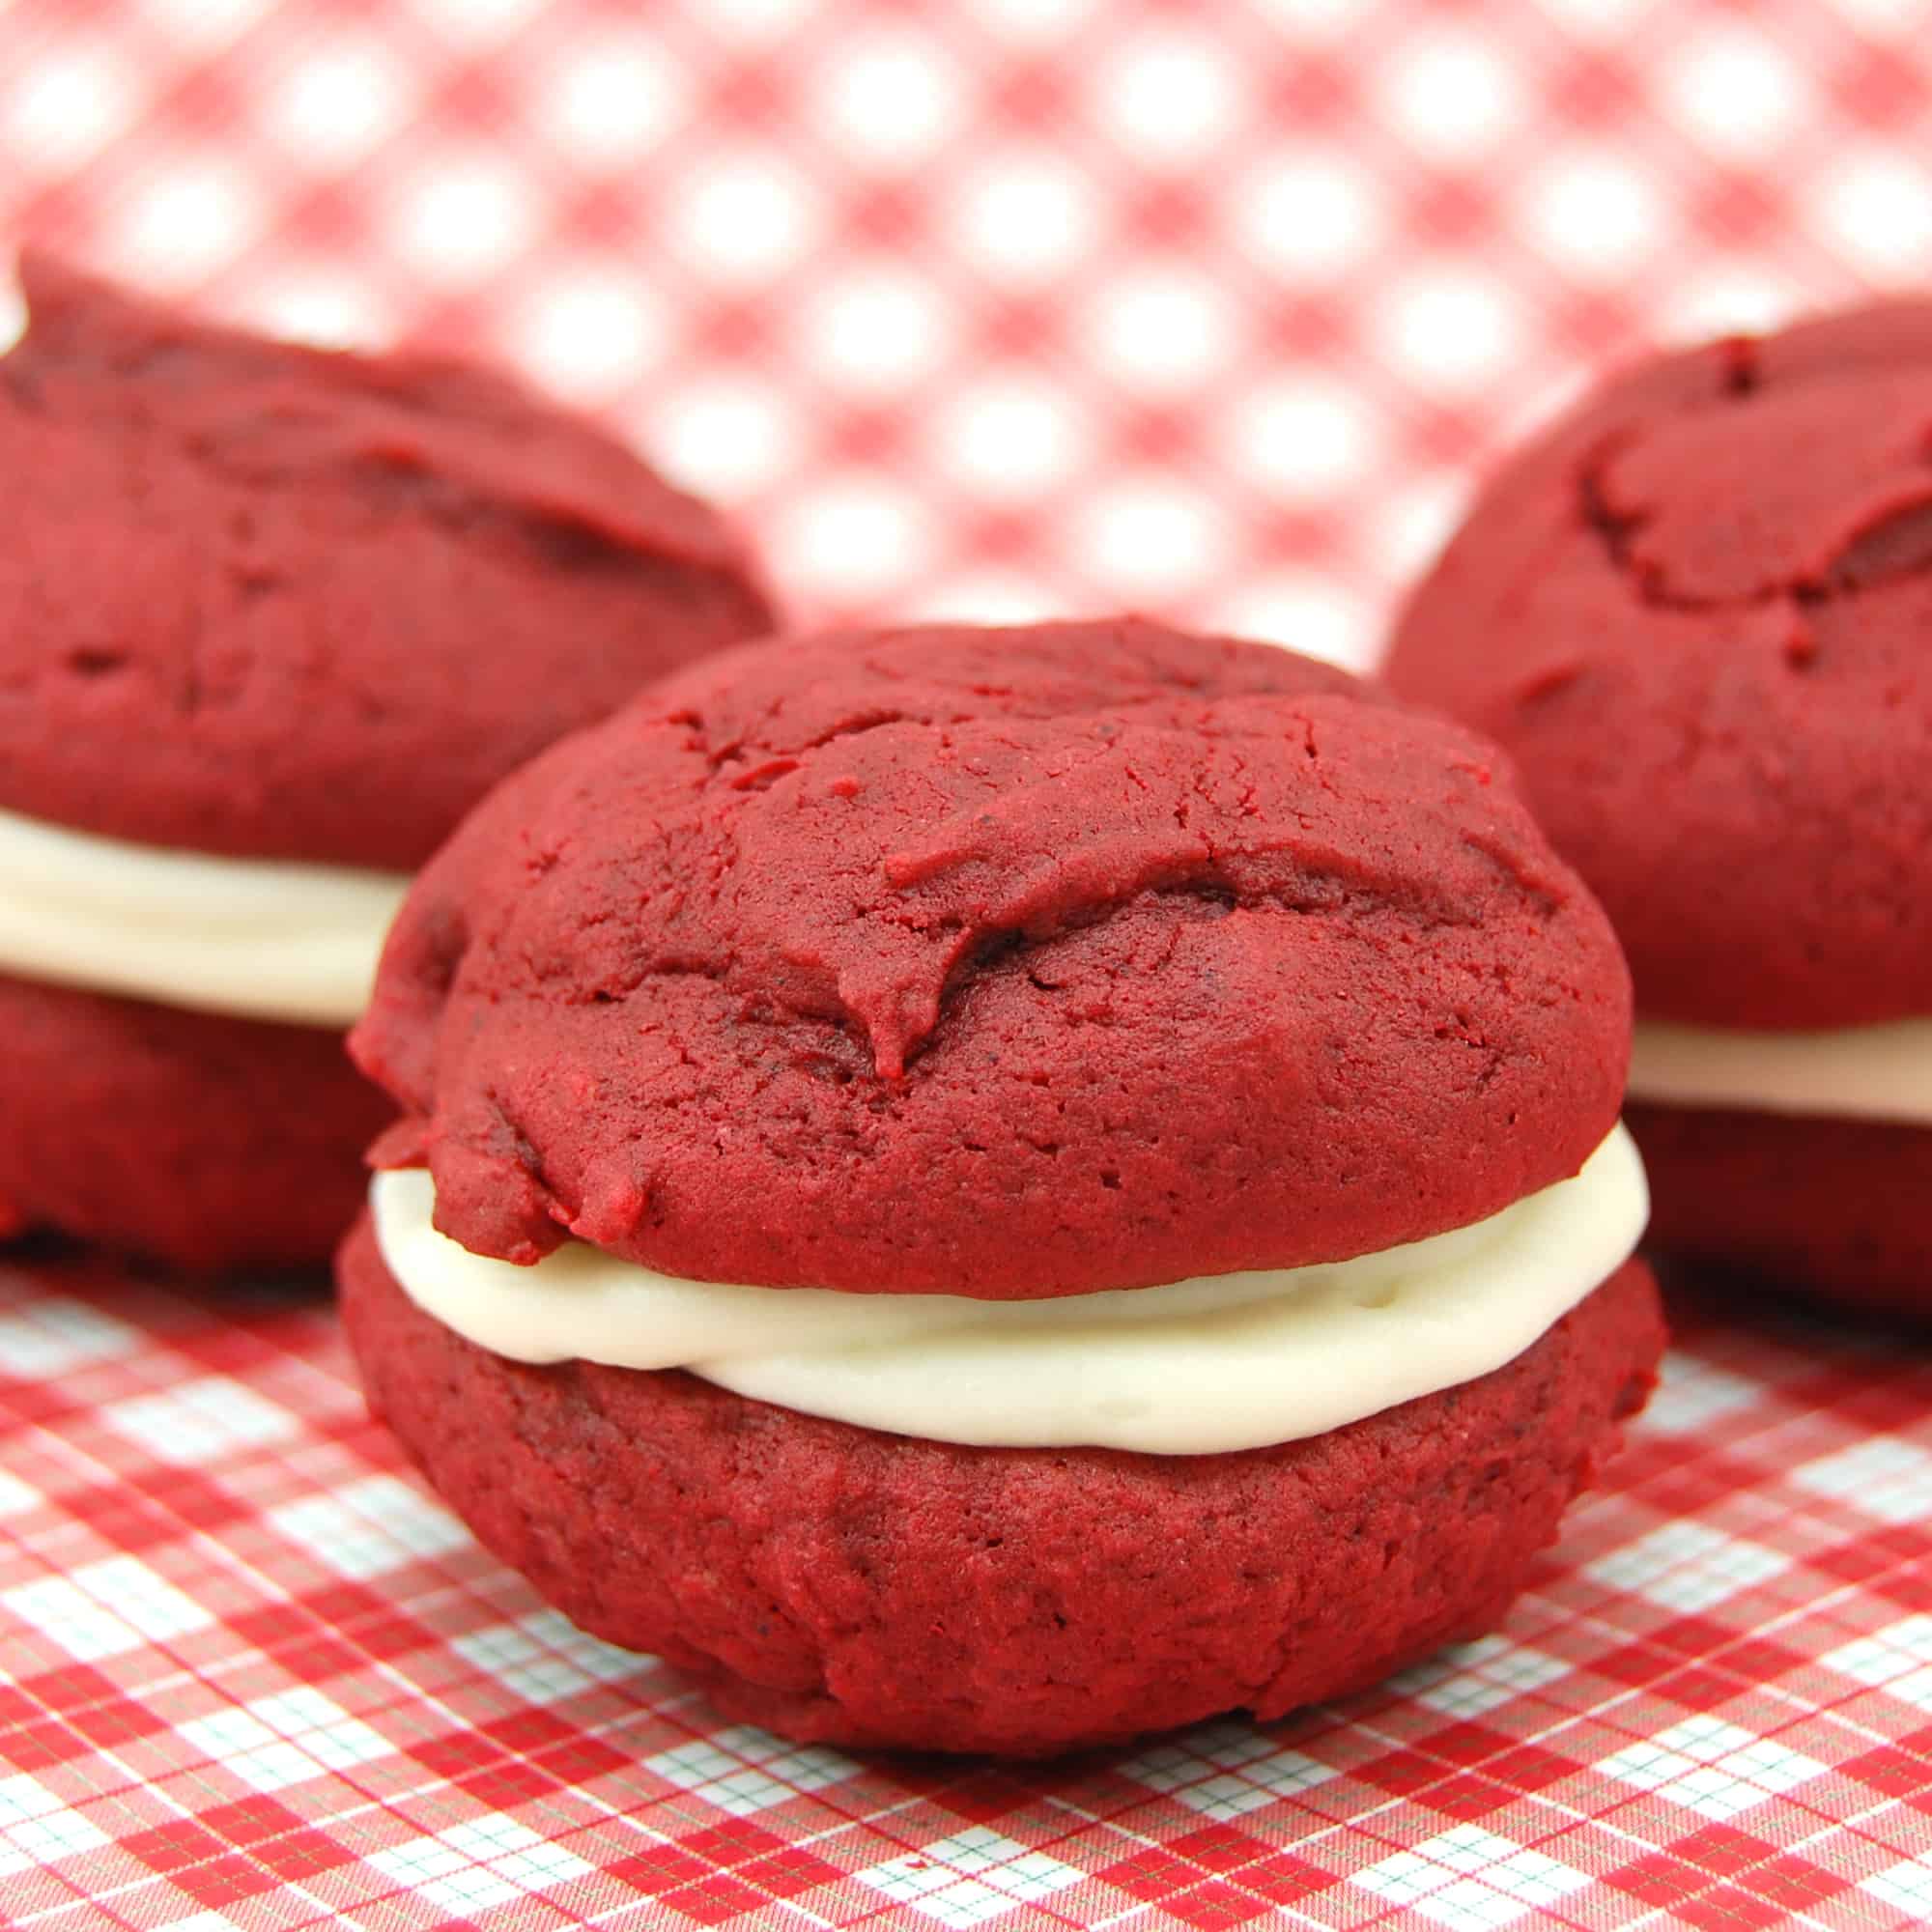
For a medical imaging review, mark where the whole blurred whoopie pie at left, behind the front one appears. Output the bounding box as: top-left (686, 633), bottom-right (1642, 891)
top-left (0, 253), bottom-right (771, 1267)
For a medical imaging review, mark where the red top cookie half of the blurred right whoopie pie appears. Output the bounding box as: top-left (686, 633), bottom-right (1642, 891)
top-left (1387, 303), bottom-right (1932, 1028)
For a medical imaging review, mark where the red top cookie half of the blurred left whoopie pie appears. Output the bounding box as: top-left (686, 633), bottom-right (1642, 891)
top-left (0, 253), bottom-right (771, 867)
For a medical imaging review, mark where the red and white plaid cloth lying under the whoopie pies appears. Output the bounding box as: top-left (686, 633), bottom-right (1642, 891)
top-left (0, 1264), bottom-right (1932, 1932)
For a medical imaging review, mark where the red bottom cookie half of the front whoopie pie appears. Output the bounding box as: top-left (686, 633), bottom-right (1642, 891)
top-left (338, 1219), bottom-right (1663, 1756)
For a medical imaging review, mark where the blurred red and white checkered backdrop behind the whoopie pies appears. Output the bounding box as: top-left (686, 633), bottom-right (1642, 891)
top-left (11, 0), bottom-right (1932, 663)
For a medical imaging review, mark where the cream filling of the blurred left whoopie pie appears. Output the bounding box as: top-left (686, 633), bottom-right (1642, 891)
top-left (0, 811), bottom-right (410, 1026)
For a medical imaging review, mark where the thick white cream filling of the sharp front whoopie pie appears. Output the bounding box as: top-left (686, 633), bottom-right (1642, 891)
top-left (369, 1124), bottom-right (1650, 1455)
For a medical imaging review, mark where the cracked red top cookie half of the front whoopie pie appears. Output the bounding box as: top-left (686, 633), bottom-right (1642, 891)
top-left (352, 620), bottom-right (1631, 1298)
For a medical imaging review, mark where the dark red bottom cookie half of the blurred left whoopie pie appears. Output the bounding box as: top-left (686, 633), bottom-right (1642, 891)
top-left (0, 978), bottom-right (394, 1271)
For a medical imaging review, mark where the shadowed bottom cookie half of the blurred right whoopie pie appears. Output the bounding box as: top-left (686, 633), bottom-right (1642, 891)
top-left (1625, 1101), bottom-right (1932, 1321)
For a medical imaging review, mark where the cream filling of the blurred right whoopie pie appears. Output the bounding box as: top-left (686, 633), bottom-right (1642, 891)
top-left (1631, 1020), bottom-right (1932, 1126)
